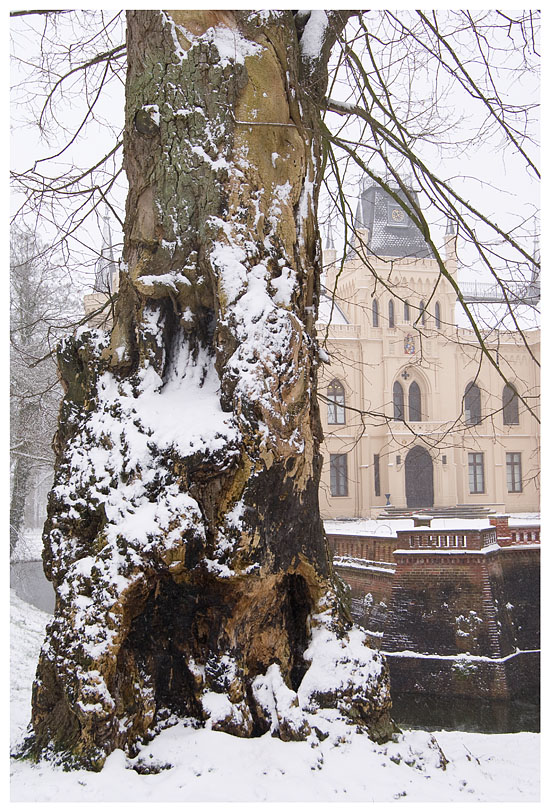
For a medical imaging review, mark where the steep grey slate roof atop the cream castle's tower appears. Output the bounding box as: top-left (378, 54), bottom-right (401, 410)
top-left (355, 184), bottom-right (433, 258)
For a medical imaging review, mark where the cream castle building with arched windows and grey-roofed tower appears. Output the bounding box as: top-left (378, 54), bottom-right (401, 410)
top-left (318, 183), bottom-right (540, 518)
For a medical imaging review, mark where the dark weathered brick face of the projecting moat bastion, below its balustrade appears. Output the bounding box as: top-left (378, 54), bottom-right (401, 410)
top-left (382, 547), bottom-right (540, 699)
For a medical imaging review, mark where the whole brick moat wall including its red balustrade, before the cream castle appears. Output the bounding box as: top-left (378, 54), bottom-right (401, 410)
top-left (329, 525), bottom-right (540, 699)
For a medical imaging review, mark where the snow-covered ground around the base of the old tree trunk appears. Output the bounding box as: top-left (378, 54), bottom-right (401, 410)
top-left (11, 591), bottom-right (540, 803)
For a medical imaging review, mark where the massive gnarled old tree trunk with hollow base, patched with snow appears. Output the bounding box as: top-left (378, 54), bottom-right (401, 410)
top-left (26, 11), bottom-right (392, 769)
